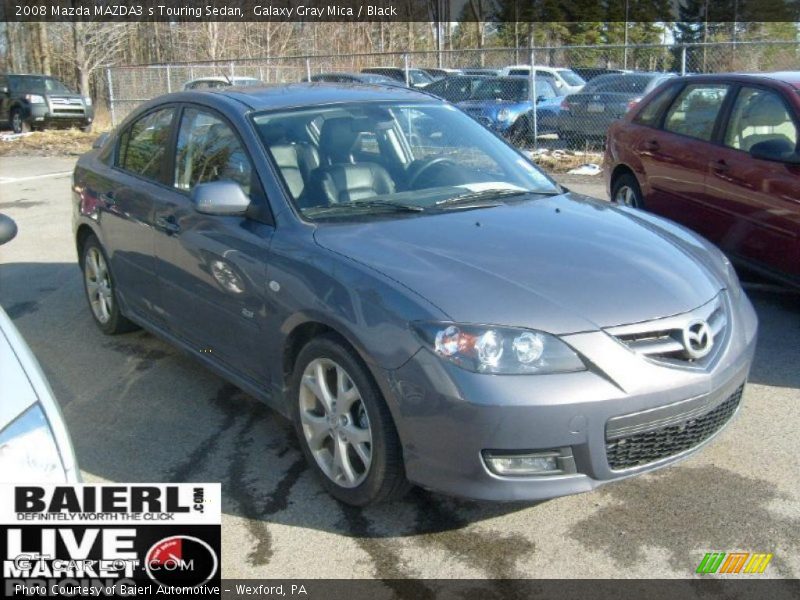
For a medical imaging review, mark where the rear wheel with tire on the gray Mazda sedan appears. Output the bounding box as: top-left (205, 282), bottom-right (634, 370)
top-left (81, 236), bottom-right (138, 335)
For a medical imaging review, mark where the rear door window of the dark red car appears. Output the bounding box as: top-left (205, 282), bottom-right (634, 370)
top-left (664, 84), bottom-right (728, 141)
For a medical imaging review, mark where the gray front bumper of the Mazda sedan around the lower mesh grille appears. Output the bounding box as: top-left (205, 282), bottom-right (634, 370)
top-left (383, 294), bottom-right (757, 501)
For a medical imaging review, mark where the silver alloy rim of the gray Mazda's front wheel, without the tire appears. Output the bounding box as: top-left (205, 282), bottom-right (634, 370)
top-left (299, 358), bottom-right (372, 488)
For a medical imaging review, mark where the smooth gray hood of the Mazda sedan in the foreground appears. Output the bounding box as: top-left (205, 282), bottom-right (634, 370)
top-left (315, 193), bottom-right (725, 334)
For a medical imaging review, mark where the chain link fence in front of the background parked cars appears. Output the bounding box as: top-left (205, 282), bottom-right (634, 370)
top-left (106, 42), bottom-right (800, 170)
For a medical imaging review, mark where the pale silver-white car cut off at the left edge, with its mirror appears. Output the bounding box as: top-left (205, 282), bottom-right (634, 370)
top-left (0, 215), bottom-right (80, 483)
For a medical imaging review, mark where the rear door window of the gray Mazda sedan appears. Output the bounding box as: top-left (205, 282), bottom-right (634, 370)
top-left (117, 108), bottom-right (175, 180)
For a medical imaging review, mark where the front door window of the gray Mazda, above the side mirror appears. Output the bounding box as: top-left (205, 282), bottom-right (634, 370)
top-left (174, 108), bottom-right (253, 194)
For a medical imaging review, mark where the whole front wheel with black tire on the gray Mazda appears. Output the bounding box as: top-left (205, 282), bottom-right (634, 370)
top-left (290, 336), bottom-right (409, 506)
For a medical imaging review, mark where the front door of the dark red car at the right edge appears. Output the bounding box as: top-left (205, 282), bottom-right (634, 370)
top-left (706, 85), bottom-right (800, 277)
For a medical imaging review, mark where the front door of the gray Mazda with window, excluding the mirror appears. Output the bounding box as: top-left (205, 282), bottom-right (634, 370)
top-left (155, 105), bottom-right (273, 385)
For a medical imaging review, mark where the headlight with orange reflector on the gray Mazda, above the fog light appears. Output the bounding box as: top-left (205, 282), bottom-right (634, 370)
top-left (414, 323), bottom-right (586, 374)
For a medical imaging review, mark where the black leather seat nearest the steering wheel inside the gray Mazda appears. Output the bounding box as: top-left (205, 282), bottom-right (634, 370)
top-left (305, 117), bottom-right (395, 206)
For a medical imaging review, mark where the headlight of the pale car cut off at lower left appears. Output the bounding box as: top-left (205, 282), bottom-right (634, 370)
top-left (0, 404), bottom-right (67, 483)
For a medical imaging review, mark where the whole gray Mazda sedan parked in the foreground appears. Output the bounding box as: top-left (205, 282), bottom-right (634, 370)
top-left (74, 84), bottom-right (756, 505)
